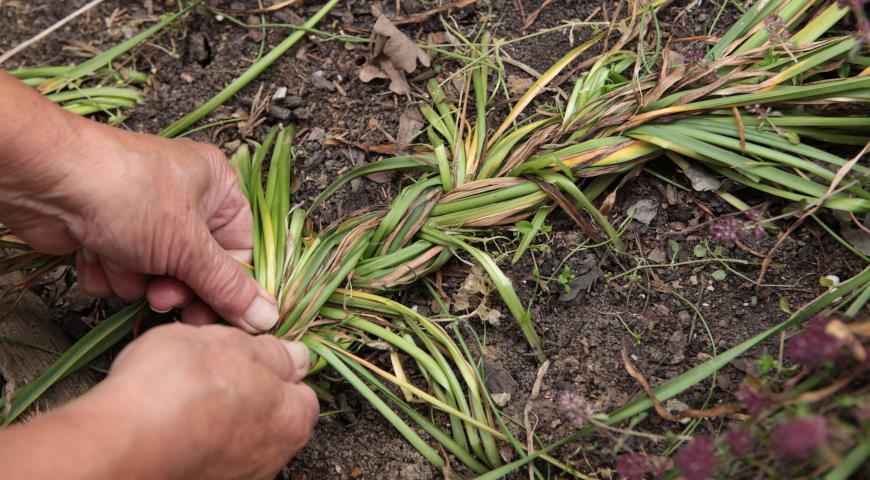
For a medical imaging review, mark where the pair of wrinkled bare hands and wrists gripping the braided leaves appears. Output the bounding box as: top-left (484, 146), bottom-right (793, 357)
top-left (0, 71), bottom-right (318, 479)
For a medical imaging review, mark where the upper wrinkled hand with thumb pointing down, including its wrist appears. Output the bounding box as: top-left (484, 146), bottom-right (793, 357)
top-left (0, 75), bottom-right (278, 332)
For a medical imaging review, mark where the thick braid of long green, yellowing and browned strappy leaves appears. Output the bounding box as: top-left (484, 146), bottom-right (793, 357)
top-left (1, 0), bottom-right (870, 478)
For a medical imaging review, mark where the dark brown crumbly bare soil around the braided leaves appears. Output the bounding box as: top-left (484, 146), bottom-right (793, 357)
top-left (0, 0), bottom-right (859, 479)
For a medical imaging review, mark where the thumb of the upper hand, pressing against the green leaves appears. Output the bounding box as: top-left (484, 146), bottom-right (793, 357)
top-left (175, 224), bottom-right (278, 333)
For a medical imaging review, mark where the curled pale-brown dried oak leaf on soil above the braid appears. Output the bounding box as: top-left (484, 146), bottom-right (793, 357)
top-left (359, 15), bottom-right (431, 94)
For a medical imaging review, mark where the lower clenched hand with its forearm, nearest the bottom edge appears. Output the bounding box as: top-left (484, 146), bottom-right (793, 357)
top-left (0, 323), bottom-right (318, 480)
